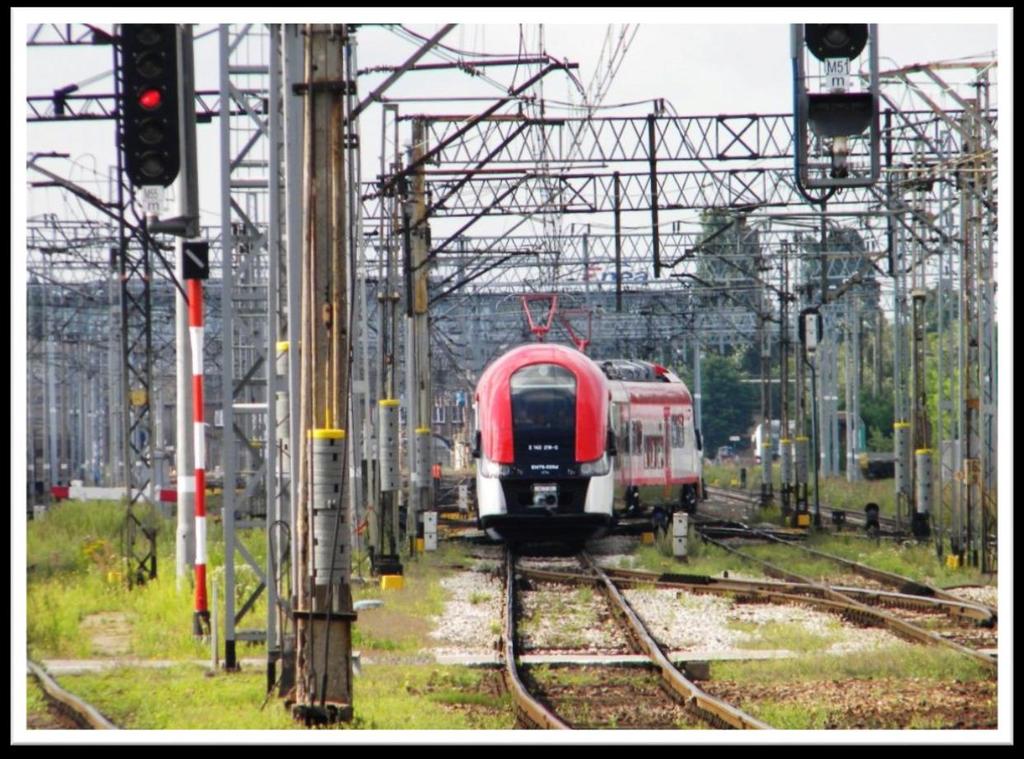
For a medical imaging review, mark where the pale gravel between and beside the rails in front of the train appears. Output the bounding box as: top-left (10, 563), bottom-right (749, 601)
top-left (430, 537), bottom-right (909, 657)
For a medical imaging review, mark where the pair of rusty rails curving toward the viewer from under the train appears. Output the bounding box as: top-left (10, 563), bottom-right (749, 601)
top-left (503, 552), bottom-right (769, 729)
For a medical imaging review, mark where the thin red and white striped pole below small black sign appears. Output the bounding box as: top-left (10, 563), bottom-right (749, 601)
top-left (187, 279), bottom-right (210, 635)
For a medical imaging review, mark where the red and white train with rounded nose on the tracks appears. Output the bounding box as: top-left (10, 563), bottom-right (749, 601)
top-left (474, 343), bottom-right (703, 542)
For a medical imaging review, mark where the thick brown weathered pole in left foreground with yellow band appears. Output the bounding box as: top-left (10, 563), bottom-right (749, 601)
top-left (293, 25), bottom-right (355, 724)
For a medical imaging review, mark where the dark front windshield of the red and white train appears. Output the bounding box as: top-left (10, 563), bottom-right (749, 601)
top-left (511, 364), bottom-right (577, 467)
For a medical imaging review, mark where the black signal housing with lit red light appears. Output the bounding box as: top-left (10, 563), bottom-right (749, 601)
top-left (121, 24), bottom-right (181, 187)
